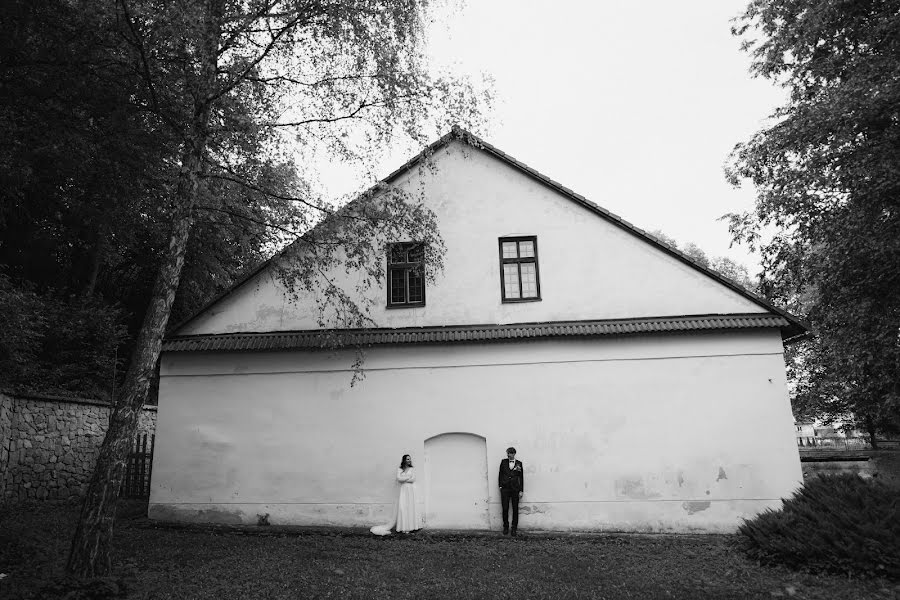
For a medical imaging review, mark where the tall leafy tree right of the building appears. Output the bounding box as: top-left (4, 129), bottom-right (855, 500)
top-left (728, 0), bottom-right (900, 442)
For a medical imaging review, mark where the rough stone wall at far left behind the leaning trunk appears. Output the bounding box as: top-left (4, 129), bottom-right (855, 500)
top-left (0, 394), bottom-right (156, 501)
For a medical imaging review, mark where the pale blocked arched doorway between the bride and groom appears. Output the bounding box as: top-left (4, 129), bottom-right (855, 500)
top-left (425, 433), bottom-right (490, 529)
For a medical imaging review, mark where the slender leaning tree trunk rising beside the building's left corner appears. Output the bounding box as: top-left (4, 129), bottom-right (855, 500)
top-left (66, 144), bottom-right (201, 577)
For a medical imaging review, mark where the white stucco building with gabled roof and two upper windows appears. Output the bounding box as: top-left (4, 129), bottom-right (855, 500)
top-left (150, 130), bottom-right (805, 531)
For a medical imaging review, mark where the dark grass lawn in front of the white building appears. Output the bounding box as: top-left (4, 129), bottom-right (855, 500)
top-left (0, 503), bottom-right (900, 600)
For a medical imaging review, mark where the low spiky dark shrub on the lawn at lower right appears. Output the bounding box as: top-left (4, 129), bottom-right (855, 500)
top-left (738, 475), bottom-right (900, 579)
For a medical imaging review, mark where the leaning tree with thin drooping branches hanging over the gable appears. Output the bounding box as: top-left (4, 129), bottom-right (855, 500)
top-left (50, 0), bottom-right (483, 576)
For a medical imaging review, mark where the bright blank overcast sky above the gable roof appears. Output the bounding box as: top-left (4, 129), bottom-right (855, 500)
top-left (312, 0), bottom-right (786, 274)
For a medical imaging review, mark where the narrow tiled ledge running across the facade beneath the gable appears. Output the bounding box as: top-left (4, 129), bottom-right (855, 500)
top-left (163, 314), bottom-right (790, 352)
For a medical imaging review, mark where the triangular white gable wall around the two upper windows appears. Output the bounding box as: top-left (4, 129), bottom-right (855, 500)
top-left (179, 142), bottom-right (767, 335)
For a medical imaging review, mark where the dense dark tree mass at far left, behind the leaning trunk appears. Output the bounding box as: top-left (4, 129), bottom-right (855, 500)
top-left (0, 0), bottom-right (171, 398)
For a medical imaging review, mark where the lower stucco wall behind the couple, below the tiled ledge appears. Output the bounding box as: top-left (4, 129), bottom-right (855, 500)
top-left (150, 330), bottom-right (802, 531)
